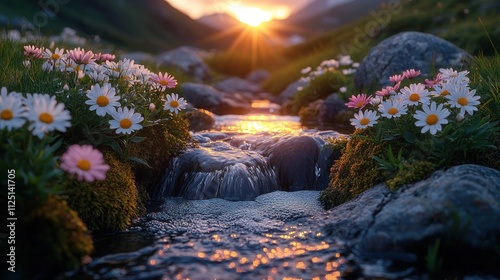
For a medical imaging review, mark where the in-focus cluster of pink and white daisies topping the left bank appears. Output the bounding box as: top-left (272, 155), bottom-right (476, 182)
top-left (24, 46), bottom-right (187, 134)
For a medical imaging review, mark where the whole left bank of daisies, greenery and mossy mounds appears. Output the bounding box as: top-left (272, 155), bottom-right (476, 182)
top-left (0, 42), bottom-right (190, 277)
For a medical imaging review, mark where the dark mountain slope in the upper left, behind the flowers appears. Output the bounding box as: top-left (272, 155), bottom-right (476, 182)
top-left (0, 0), bottom-right (216, 52)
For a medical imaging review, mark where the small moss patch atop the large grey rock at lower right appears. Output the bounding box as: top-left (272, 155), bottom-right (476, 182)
top-left (386, 161), bottom-right (436, 191)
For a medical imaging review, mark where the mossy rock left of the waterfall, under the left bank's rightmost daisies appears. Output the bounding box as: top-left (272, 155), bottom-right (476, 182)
top-left (128, 114), bottom-right (191, 194)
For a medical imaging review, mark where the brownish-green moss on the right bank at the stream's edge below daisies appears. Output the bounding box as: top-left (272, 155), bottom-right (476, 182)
top-left (320, 130), bottom-right (385, 209)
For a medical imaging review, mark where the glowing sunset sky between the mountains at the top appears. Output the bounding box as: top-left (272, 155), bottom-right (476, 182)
top-left (170, 0), bottom-right (312, 19)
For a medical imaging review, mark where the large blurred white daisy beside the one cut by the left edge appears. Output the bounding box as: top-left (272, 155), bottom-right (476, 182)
top-left (25, 93), bottom-right (71, 139)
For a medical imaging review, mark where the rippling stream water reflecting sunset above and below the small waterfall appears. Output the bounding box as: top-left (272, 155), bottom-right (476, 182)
top-left (61, 115), bottom-right (428, 279)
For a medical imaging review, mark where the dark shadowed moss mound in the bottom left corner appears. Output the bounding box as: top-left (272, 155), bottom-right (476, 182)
top-left (16, 196), bottom-right (94, 278)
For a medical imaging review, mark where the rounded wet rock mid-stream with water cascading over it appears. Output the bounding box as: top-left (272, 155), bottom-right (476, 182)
top-left (157, 142), bottom-right (278, 200)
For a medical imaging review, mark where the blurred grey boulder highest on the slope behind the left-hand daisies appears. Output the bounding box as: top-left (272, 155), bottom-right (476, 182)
top-left (157, 47), bottom-right (210, 82)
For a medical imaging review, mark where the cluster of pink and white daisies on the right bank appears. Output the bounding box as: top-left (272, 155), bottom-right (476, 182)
top-left (346, 68), bottom-right (480, 135)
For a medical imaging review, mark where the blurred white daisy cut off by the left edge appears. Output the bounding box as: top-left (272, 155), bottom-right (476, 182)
top-left (0, 87), bottom-right (26, 131)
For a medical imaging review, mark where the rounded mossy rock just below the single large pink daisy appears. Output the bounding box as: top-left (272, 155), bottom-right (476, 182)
top-left (67, 150), bottom-right (139, 231)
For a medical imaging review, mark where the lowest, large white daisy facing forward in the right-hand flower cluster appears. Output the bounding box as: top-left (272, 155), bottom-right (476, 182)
top-left (413, 102), bottom-right (450, 135)
